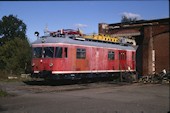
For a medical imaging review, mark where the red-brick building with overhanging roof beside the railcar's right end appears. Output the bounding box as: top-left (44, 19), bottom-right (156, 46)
top-left (98, 18), bottom-right (170, 75)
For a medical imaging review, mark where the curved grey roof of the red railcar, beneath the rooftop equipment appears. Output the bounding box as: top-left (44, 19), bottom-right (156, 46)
top-left (32, 37), bottom-right (135, 50)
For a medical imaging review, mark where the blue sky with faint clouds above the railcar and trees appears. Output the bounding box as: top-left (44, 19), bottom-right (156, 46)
top-left (0, 0), bottom-right (169, 43)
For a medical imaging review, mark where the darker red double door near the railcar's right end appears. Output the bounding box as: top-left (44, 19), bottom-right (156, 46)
top-left (119, 50), bottom-right (127, 70)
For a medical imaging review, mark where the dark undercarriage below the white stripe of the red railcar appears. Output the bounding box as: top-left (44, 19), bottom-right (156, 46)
top-left (31, 71), bottom-right (138, 82)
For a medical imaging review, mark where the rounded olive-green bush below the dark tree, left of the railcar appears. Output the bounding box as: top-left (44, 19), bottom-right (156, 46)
top-left (0, 38), bottom-right (31, 74)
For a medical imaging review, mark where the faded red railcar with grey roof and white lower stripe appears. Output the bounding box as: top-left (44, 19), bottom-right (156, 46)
top-left (32, 36), bottom-right (136, 79)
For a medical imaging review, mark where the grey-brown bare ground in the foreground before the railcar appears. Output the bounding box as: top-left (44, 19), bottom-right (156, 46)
top-left (0, 81), bottom-right (170, 113)
